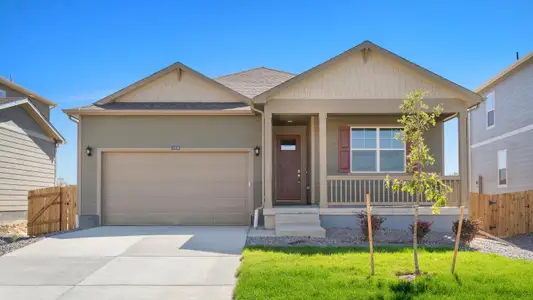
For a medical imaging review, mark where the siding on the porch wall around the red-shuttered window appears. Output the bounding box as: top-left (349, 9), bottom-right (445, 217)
top-left (327, 116), bottom-right (444, 175)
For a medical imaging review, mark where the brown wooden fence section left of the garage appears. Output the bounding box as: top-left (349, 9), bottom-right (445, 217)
top-left (28, 185), bottom-right (77, 235)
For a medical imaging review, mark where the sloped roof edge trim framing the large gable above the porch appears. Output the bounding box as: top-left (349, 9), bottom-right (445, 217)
top-left (254, 41), bottom-right (482, 105)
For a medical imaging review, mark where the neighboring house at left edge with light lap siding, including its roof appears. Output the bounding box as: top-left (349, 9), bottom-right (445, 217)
top-left (0, 77), bottom-right (65, 224)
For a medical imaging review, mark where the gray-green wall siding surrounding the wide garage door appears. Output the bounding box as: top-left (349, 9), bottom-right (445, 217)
top-left (80, 116), bottom-right (261, 215)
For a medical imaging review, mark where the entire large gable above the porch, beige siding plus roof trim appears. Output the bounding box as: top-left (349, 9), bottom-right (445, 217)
top-left (254, 41), bottom-right (481, 104)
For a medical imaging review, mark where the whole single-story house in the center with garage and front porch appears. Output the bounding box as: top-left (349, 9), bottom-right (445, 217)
top-left (65, 41), bottom-right (481, 236)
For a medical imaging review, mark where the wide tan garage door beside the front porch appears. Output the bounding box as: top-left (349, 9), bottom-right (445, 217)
top-left (102, 152), bottom-right (250, 225)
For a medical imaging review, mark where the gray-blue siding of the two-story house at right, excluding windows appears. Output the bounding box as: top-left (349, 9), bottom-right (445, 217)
top-left (470, 63), bottom-right (533, 194)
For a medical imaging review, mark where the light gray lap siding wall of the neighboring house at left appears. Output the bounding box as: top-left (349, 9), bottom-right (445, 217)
top-left (0, 107), bottom-right (56, 212)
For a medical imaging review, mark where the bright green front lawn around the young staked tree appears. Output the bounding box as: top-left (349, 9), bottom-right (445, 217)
top-left (235, 247), bottom-right (533, 300)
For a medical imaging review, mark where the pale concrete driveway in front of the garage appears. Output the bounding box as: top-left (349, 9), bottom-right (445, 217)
top-left (0, 226), bottom-right (248, 300)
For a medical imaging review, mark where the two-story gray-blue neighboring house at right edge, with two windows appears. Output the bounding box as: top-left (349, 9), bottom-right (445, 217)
top-left (470, 52), bottom-right (533, 194)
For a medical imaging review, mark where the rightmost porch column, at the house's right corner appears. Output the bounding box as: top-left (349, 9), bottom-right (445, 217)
top-left (458, 109), bottom-right (469, 207)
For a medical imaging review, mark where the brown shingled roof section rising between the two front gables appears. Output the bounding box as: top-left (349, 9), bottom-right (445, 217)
top-left (214, 67), bottom-right (296, 98)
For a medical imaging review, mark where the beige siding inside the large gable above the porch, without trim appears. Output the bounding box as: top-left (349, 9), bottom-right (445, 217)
top-left (272, 51), bottom-right (461, 99)
